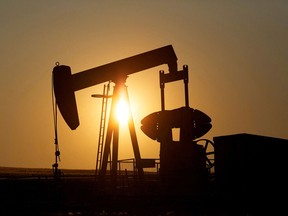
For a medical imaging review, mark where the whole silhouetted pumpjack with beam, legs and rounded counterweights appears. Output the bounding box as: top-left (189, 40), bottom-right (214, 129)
top-left (53, 45), bottom-right (212, 190)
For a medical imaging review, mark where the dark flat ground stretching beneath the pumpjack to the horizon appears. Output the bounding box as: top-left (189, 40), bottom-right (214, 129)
top-left (0, 167), bottom-right (276, 216)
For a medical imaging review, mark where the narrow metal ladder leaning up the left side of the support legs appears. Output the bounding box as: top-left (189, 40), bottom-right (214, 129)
top-left (95, 81), bottom-right (110, 175)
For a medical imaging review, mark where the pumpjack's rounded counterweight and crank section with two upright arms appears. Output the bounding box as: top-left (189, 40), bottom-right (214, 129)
top-left (141, 65), bottom-right (213, 194)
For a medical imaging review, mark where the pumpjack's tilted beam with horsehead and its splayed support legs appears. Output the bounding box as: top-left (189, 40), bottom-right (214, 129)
top-left (53, 45), bottom-right (178, 182)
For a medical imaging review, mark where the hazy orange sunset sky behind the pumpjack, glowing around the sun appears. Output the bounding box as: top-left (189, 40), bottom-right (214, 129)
top-left (0, 0), bottom-right (288, 169)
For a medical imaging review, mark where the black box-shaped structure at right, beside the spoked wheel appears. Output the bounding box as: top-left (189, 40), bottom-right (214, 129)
top-left (213, 133), bottom-right (288, 215)
